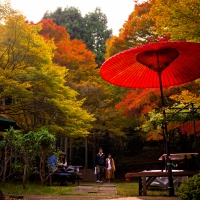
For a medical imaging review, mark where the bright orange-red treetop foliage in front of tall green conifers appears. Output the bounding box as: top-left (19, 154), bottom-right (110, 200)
top-left (40, 19), bottom-right (96, 70)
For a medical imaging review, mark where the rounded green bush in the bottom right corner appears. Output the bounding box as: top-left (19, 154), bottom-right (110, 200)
top-left (178, 174), bottom-right (200, 200)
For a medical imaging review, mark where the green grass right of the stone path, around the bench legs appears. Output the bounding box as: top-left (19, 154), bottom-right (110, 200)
top-left (115, 182), bottom-right (178, 197)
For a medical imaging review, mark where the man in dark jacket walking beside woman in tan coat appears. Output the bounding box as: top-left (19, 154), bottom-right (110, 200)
top-left (95, 148), bottom-right (106, 183)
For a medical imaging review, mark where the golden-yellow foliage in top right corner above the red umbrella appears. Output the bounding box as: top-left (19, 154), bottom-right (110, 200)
top-left (150, 0), bottom-right (200, 42)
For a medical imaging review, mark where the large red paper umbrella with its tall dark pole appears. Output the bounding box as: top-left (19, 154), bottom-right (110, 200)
top-left (100, 42), bottom-right (200, 196)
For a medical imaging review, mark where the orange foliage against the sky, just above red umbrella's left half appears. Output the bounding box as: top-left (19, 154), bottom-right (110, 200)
top-left (106, 2), bottom-right (156, 58)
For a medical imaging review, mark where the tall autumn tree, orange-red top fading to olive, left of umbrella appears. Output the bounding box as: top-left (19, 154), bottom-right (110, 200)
top-left (40, 20), bottom-right (131, 166)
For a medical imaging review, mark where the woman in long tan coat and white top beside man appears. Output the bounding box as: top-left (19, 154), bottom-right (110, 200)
top-left (106, 154), bottom-right (115, 183)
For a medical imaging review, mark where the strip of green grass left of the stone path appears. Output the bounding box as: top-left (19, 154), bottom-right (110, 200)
top-left (0, 183), bottom-right (77, 195)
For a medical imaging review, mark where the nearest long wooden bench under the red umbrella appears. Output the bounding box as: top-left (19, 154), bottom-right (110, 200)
top-left (125, 170), bottom-right (199, 196)
